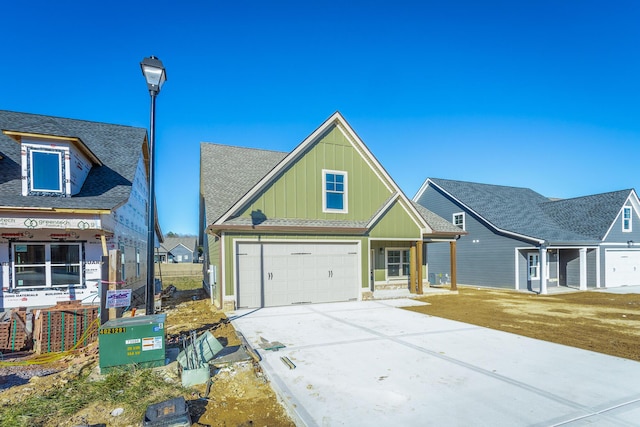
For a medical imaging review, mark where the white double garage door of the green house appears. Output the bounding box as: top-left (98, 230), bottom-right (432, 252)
top-left (236, 243), bottom-right (360, 308)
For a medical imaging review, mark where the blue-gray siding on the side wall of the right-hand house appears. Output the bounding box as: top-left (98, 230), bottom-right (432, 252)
top-left (418, 186), bottom-right (535, 289)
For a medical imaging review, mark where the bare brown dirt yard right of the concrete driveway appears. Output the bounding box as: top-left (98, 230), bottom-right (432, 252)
top-left (408, 287), bottom-right (640, 361)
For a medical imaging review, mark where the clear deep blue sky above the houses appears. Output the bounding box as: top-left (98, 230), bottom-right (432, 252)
top-left (0, 0), bottom-right (640, 234)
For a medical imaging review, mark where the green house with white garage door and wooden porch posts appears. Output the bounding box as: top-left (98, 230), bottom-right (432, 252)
top-left (200, 113), bottom-right (464, 309)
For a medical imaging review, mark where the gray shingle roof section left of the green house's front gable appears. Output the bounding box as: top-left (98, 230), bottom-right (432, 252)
top-left (200, 143), bottom-right (288, 224)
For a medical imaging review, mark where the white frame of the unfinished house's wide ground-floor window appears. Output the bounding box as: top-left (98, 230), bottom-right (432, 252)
top-left (10, 241), bottom-right (85, 290)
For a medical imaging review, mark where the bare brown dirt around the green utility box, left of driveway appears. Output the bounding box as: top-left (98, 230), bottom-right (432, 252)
top-left (0, 290), bottom-right (294, 427)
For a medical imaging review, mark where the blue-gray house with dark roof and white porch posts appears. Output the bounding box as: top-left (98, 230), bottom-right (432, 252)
top-left (413, 178), bottom-right (640, 293)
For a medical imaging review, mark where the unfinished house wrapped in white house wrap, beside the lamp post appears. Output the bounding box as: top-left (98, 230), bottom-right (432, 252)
top-left (0, 111), bottom-right (160, 310)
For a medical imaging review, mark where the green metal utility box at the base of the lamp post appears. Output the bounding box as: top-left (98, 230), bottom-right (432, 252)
top-left (98, 314), bottom-right (166, 373)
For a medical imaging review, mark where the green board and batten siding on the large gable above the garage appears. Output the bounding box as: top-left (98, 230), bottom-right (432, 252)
top-left (240, 126), bottom-right (392, 221)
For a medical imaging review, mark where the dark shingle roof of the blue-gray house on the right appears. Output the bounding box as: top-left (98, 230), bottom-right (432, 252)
top-left (430, 178), bottom-right (631, 243)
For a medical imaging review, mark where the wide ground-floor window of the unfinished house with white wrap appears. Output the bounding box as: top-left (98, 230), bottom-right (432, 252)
top-left (13, 243), bottom-right (82, 288)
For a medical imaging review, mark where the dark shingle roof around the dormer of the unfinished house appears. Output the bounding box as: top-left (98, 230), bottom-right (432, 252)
top-left (0, 110), bottom-right (146, 209)
